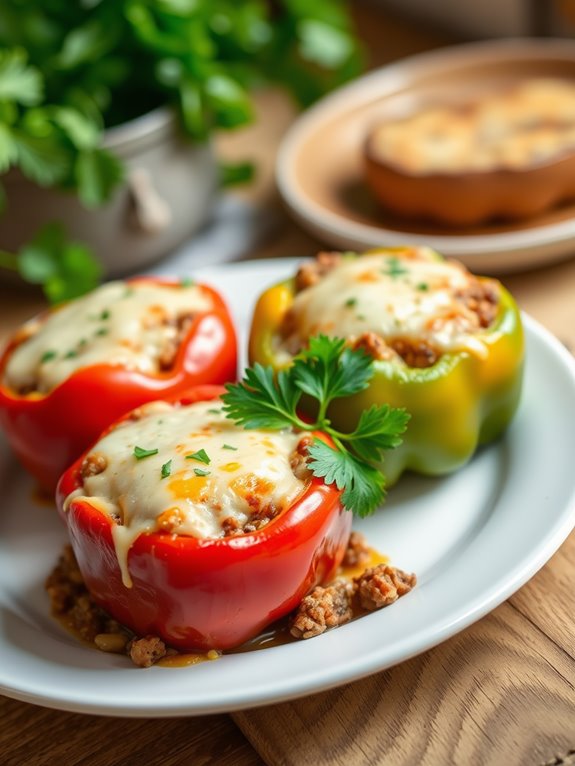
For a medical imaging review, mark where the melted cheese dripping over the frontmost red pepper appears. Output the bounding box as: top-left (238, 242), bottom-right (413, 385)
top-left (65, 400), bottom-right (305, 586)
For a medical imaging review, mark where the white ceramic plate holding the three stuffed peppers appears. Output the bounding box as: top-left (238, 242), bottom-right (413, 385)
top-left (0, 260), bottom-right (575, 716)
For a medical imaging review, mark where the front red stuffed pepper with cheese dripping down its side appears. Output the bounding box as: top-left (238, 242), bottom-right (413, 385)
top-left (57, 386), bottom-right (352, 651)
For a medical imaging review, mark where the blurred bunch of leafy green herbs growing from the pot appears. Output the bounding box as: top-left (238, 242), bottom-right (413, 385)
top-left (0, 0), bottom-right (361, 304)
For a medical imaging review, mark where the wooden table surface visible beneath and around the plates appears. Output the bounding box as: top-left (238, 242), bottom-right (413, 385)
top-left (0, 7), bottom-right (575, 766)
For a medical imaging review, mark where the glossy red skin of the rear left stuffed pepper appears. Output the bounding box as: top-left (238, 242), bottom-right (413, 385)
top-left (0, 277), bottom-right (237, 492)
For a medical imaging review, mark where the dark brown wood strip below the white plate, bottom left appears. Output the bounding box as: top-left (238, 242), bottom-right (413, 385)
top-left (0, 697), bottom-right (264, 766)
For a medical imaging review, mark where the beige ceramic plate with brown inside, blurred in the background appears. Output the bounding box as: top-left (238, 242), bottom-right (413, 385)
top-left (276, 40), bottom-right (575, 274)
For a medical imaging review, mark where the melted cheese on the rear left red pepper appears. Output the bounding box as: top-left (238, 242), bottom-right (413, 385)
top-left (4, 282), bottom-right (212, 393)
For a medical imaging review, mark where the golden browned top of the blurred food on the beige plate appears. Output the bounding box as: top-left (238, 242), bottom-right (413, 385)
top-left (371, 79), bottom-right (575, 174)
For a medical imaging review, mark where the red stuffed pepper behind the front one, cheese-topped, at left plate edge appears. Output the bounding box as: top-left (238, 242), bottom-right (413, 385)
top-left (0, 277), bottom-right (237, 491)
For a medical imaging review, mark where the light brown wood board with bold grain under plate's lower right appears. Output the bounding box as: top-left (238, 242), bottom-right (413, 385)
top-left (234, 537), bottom-right (575, 766)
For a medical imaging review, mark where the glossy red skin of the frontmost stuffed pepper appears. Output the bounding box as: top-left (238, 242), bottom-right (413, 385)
top-left (57, 387), bottom-right (352, 651)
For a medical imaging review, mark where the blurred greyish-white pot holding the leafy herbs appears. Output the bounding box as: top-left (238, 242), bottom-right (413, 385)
top-left (0, 108), bottom-right (217, 277)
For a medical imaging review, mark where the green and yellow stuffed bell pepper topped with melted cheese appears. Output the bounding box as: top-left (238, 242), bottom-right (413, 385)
top-left (249, 247), bottom-right (524, 485)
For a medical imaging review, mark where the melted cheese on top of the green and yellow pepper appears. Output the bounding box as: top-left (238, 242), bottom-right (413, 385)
top-left (279, 248), bottom-right (487, 357)
